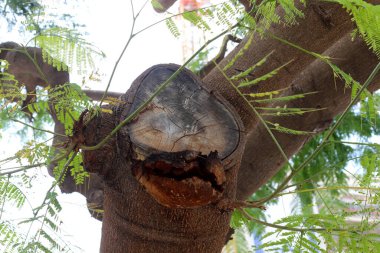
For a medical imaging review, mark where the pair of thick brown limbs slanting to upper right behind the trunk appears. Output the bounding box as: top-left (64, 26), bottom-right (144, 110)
top-left (203, 1), bottom-right (379, 199)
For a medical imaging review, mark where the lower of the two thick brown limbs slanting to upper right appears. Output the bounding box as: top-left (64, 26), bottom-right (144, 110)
top-left (237, 34), bottom-right (380, 199)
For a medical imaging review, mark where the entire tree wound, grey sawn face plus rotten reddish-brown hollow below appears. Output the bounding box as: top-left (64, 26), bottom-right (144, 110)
top-left (118, 64), bottom-right (240, 208)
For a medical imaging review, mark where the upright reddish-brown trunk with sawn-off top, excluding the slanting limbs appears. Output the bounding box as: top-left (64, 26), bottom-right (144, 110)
top-left (84, 65), bottom-right (244, 252)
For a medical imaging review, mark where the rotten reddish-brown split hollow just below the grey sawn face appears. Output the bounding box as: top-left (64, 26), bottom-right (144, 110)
top-left (132, 151), bottom-right (226, 208)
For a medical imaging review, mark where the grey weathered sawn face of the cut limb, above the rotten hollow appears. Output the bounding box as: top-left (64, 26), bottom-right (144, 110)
top-left (124, 64), bottom-right (240, 159)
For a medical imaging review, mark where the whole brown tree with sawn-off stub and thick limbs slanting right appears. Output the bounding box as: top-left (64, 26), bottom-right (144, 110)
top-left (2, 0), bottom-right (380, 252)
